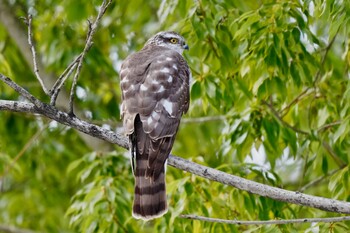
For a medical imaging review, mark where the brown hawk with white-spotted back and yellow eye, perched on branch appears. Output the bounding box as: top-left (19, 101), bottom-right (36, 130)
top-left (120, 31), bottom-right (191, 220)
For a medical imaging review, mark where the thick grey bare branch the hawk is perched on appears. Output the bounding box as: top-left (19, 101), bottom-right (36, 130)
top-left (0, 97), bottom-right (350, 214)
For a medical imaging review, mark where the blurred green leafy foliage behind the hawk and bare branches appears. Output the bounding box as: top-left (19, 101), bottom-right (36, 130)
top-left (0, 0), bottom-right (350, 232)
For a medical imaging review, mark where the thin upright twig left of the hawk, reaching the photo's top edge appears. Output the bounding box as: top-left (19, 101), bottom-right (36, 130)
top-left (69, 0), bottom-right (112, 115)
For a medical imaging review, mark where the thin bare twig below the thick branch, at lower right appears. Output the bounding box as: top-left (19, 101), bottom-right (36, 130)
top-left (179, 215), bottom-right (350, 225)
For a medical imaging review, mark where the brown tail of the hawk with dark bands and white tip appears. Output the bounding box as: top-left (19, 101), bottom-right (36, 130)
top-left (132, 156), bottom-right (168, 220)
